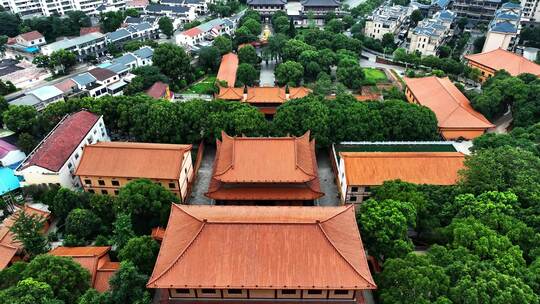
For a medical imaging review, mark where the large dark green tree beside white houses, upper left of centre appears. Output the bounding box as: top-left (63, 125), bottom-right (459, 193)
top-left (152, 43), bottom-right (191, 88)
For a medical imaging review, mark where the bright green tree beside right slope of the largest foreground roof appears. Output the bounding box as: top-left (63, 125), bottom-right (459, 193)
top-left (357, 199), bottom-right (416, 260)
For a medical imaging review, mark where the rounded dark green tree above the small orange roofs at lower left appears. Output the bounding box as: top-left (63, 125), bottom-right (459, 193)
top-left (66, 208), bottom-right (102, 242)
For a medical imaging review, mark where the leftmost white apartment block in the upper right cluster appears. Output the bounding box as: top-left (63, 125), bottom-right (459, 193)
top-left (364, 5), bottom-right (411, 40)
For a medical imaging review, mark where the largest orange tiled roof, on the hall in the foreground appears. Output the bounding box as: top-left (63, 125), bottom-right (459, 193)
top-left (147, 205), bottom-right (376, 290)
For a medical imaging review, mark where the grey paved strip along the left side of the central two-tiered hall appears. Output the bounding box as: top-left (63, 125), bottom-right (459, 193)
top-left (188, 145), bottom-right (216, 205)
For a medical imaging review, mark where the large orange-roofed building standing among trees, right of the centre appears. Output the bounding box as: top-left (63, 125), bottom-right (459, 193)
top-left (404, 76), bottom-right (494, 140)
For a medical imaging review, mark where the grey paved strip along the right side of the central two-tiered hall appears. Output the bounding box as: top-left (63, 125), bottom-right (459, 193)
top-left (317, 150), bottom-right (339, 206)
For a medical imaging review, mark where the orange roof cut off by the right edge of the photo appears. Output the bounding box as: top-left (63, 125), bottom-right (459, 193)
top-left (465, 48), bottom-right (540, 76)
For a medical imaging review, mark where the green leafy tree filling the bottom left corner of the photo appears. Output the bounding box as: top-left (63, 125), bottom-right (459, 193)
top-left (0, 278), bottom-right (64, 304)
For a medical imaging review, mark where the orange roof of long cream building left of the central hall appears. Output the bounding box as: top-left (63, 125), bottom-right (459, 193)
top-left (75, 142), bottom-right (191, 179)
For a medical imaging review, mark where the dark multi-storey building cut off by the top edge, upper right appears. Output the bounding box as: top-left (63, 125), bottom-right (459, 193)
top-left (452, 0), bottom-right (502, 22)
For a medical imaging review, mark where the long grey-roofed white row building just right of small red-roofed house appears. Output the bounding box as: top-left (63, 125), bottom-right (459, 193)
top-left (41, 32), bottom-right (106, 61)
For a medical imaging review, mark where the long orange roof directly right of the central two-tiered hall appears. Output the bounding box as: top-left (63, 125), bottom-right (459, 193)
top-left (340, 152), bottom-right (465, 186)
